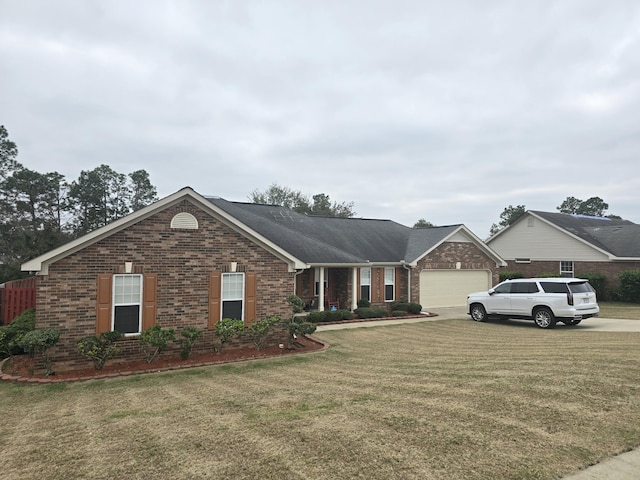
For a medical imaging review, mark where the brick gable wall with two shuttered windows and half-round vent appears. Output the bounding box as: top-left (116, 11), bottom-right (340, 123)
top-left (36, 201), bottom-right (294, 370)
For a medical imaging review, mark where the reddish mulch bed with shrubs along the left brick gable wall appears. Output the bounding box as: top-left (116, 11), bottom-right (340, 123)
top-left (0, 337), bottom-right (327, 383)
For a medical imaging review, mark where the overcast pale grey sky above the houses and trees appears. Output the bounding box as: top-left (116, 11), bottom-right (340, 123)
top-left (0, 0), bottom-right (640, 238)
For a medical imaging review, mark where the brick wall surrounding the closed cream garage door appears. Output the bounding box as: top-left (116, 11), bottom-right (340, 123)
top-left (411, 242), bottom-right (500, 302)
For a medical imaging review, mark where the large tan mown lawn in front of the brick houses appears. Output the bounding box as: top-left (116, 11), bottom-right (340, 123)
top-left (0, 320), bottom-right (640, 480)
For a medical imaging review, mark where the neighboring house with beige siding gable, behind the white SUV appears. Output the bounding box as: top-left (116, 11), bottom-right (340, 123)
top-left (487, 211), bottom-right (640, 289)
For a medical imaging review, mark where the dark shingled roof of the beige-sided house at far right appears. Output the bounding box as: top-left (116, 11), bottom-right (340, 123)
top-left (531, 210), bottom-right (640, 258)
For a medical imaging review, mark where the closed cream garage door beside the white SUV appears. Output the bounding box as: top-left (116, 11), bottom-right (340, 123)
top-left (420, 270), bottom-right (491, 311)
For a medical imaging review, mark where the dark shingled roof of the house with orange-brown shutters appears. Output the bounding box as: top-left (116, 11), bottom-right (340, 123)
top-left (207, 197), bottom-right (460, 264)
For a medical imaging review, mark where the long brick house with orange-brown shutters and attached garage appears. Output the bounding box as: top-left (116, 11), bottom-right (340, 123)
top-left (22, 188), bottom-right (506, 368)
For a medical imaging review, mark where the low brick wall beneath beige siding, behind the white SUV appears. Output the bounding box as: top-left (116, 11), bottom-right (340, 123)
top-left (505, 260), bottom-right (640, 290)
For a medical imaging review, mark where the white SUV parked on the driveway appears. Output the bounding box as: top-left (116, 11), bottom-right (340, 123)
top-left (467, 278), bottom-right (600, 328)
